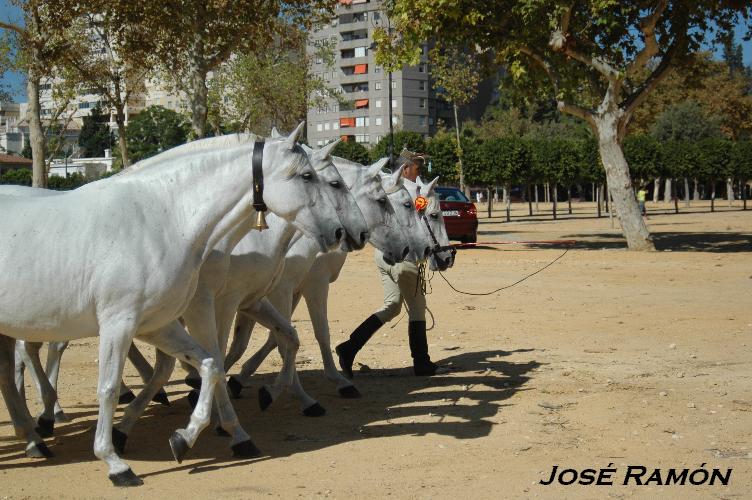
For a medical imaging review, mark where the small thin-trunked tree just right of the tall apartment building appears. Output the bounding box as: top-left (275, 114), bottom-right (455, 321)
top-left (430, 44), bottom-right (482, 194)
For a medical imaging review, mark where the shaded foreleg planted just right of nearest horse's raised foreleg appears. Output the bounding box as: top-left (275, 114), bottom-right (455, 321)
top-left (183, 295), bottom-right (259, 457)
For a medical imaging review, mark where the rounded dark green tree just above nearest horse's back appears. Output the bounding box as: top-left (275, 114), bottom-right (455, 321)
top-left (127, 106), bottom-right (189, 161)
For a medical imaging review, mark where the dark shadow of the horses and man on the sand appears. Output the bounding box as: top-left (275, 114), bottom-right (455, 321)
top-left (0, 349), bottom-right (540, 477)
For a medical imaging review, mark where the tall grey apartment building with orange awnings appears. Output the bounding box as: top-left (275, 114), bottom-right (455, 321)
top-left (307, 0), bottom-right (451, 146)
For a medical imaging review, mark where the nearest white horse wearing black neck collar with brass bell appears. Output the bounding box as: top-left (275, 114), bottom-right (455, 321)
top-left (0, 127), bottom-right (343, 486)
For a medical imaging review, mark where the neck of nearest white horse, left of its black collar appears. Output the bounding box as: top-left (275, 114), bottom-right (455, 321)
top-left (129, 147), bottom-right (253, 260)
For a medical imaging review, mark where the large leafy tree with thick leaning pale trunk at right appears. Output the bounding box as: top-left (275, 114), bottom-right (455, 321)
top-left (377, 0), bottom-right (752, 250)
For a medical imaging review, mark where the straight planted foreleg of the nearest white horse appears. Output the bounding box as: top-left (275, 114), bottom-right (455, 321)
top-left (94, 317), bottom-right (143, 486)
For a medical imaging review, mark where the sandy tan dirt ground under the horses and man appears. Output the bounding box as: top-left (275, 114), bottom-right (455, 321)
top-left (0, 201), bottom-right (752, 498)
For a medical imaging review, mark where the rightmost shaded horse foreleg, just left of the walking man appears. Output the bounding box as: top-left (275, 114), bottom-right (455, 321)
top-left (303, 280), bottom-right (360, 398)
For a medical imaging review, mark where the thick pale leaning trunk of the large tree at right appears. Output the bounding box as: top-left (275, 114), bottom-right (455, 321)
top-left (596, 117), bottom-right (655, 250)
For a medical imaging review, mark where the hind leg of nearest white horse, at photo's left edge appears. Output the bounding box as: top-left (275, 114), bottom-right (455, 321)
top-left (0, 335), bottom-right (53, 458)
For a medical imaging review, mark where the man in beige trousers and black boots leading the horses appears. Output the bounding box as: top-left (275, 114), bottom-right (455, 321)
top-left (335, 150), bottom-right (439, 378)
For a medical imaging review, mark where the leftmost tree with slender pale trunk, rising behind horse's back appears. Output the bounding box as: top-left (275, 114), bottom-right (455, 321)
top-left (0, 0), bottom-right (75, 187)
